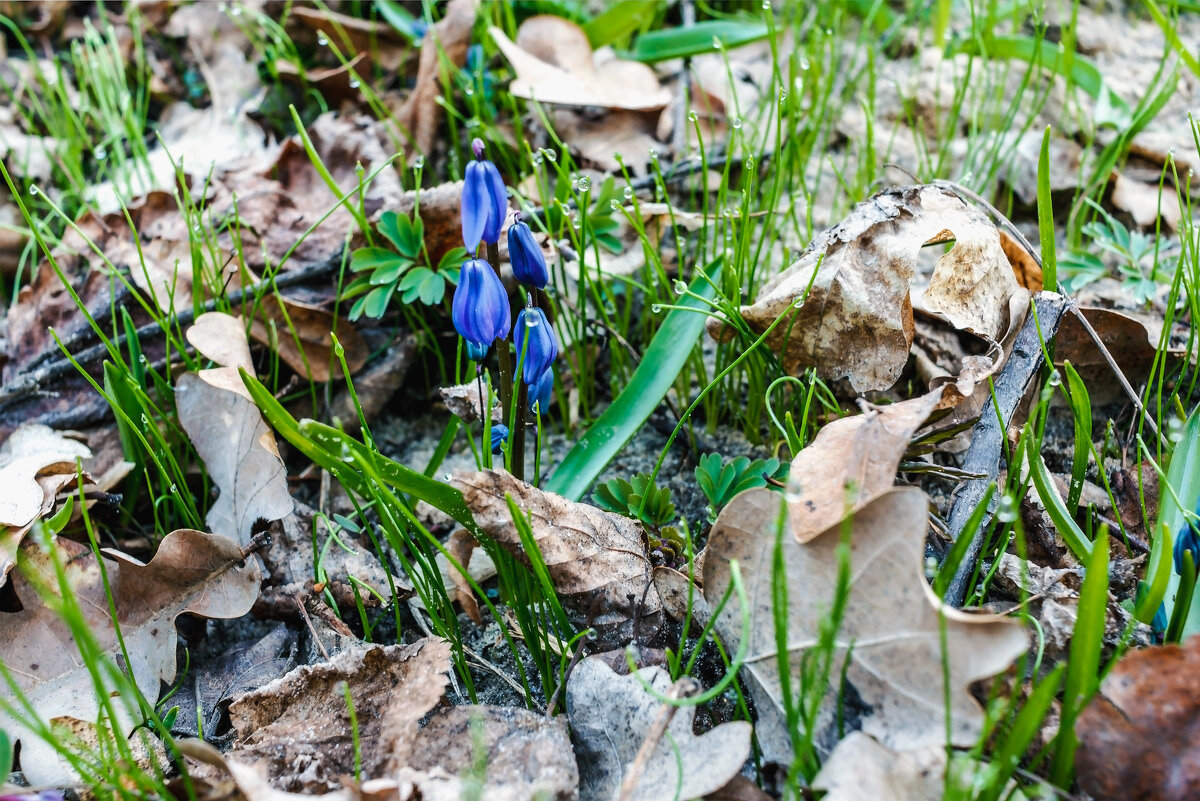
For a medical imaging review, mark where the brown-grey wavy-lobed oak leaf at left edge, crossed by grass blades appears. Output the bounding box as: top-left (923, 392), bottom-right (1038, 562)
top-left (0, 529), bottom-right (262, 785)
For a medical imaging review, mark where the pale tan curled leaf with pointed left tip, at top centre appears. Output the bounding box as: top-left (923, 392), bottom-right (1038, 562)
top-left (488, 14), bottom-right (671, 112)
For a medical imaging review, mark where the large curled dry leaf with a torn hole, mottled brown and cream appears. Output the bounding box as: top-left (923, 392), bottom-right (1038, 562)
top-left (709, 186), bottom-right (1022, 393)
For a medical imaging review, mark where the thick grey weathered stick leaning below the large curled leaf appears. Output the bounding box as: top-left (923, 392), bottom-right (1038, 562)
top-left (946, 293), bottom-right (1067, 607)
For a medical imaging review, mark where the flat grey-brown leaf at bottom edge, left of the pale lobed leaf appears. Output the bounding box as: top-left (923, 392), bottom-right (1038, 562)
top-left (400, 706), bottom-right (580, 801)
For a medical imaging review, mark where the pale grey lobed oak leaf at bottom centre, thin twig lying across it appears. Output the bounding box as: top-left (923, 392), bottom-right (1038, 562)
top-left (566, 657), bottom-right (751, 801)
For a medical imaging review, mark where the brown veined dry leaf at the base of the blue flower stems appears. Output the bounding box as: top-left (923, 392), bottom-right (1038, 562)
top-left (454, 470), bottom-right (662, 649)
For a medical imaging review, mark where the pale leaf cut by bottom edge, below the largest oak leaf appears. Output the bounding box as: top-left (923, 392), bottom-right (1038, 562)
top-left (812, 731), bottom-right (946, 801)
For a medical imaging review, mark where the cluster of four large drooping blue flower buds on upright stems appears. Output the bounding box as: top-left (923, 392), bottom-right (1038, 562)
top-left (451, 139), bottom-right (558, 422)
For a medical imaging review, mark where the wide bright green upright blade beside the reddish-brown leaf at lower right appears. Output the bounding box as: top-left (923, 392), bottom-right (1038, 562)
top-left (1050, 528), bottom-right (1109, 788)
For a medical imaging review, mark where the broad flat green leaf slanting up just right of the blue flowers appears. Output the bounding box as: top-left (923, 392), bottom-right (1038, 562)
top-left (544, 263), bottom-right (721, 500)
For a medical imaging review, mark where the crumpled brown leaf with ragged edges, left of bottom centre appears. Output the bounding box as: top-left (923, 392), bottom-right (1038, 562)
top-left (228, 637), bottom-right (450, 793)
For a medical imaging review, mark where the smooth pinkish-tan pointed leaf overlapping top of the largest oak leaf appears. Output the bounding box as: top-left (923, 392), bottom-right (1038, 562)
top-left (787, 390), bottom-right (942, 542)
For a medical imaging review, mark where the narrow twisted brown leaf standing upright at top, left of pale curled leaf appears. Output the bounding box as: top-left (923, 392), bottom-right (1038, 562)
top-left (395, 0), bottom-right (479, 155)
